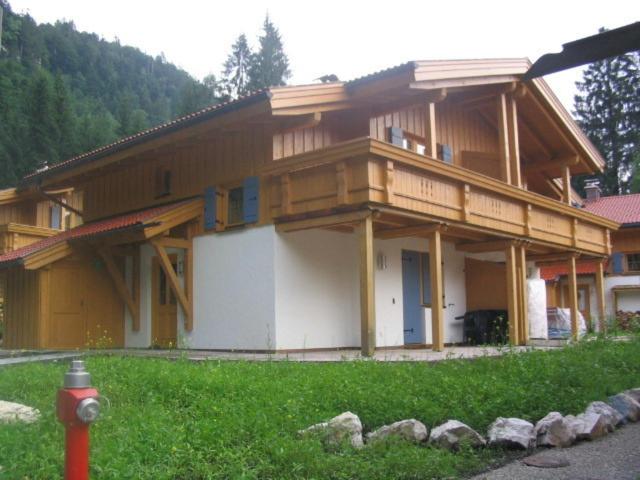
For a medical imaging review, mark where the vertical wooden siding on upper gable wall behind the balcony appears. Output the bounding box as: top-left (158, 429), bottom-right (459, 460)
top-left (369, 102), bottom-right (499, 167)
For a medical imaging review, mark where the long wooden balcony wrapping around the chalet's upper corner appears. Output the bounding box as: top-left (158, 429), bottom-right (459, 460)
top-left (262, 137), bottom-right (618, 256)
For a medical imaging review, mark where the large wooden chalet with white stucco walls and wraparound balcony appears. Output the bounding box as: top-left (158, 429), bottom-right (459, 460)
top-left (0, 59), bottom-right (618, 355)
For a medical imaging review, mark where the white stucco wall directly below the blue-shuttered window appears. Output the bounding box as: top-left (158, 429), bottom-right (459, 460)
top-left (183, 225), bottom-right (275, 350)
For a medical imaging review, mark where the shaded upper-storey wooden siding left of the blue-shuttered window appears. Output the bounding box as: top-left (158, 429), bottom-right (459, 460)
top-left (81, 128), bottom-right (271, 222)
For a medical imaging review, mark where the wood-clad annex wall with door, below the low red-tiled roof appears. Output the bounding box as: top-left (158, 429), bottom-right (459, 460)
top-left (4, 254), bottom-right (124, 349)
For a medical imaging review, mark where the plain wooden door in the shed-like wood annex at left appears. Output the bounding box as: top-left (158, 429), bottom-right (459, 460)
top-left (46, 260), bottom-right (87, 349)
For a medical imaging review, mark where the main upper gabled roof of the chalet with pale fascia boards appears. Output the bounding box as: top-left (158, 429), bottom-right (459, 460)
top-left (21, 58), bottom-right (604, 185)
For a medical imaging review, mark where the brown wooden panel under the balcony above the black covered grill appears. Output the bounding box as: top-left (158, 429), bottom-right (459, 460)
top-left (464, 257), bottom-right (507, 311)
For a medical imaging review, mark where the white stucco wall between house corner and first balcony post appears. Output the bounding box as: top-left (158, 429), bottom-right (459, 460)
top-left (275, 230), bottom-right (360, 350)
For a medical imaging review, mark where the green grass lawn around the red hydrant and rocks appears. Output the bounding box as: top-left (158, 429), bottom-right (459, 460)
top-left (0, 338), bottom-right (640, 479)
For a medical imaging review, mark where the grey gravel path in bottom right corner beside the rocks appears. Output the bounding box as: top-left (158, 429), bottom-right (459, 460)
top-left (471, 423), bottom-right (640, 480)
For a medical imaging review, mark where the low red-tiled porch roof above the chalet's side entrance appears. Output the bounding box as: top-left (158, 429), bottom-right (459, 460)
top-left (0, 199), bottom-right (201, 269)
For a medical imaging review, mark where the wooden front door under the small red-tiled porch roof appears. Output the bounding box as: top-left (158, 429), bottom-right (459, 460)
top-left (151, 255), bottom-right (178, 348)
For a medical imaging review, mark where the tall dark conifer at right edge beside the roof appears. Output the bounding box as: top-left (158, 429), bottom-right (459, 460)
top-left (574, 41), bottom-right (640, 195)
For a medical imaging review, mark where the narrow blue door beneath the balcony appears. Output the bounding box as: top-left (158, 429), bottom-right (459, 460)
top-left (402, 250), bottom-right (425, 344)
